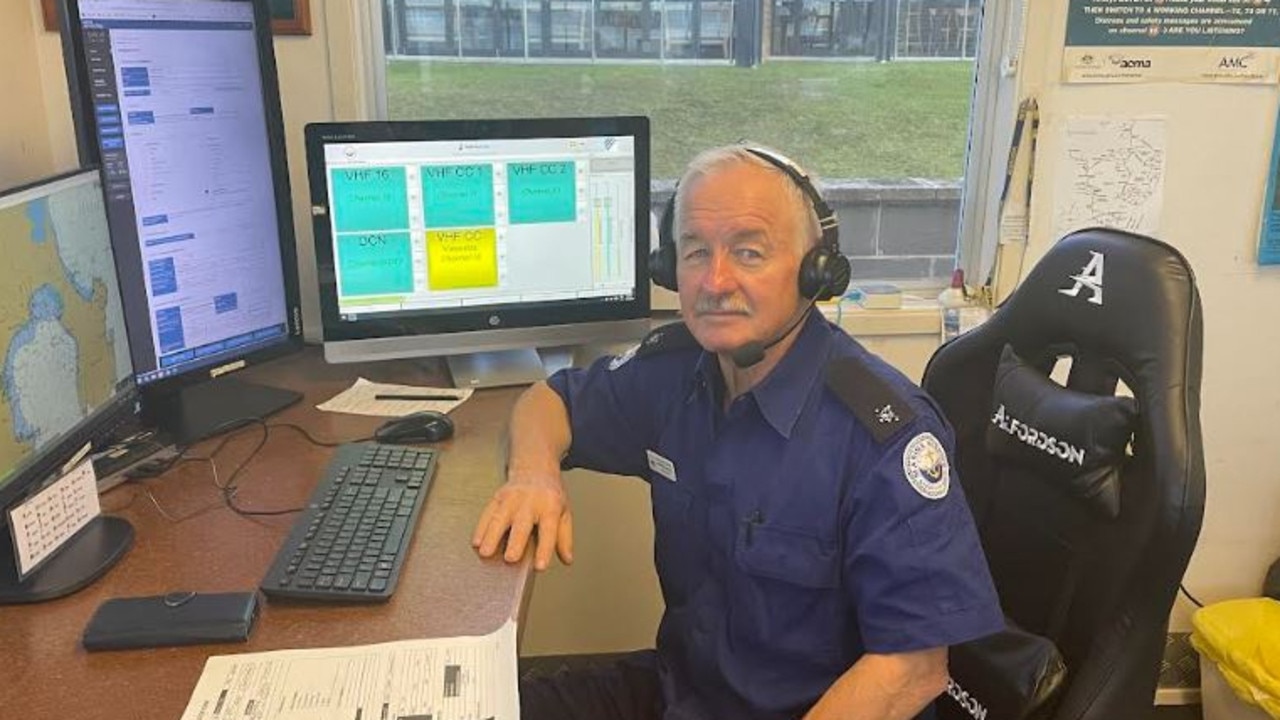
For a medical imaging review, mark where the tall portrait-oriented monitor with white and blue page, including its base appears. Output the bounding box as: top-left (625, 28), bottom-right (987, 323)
top-left (63, 0), bottom-right (302, 443)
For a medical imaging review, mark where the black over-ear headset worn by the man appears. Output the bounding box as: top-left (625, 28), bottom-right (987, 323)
top-left (649, 145), bottom-right (851, 301)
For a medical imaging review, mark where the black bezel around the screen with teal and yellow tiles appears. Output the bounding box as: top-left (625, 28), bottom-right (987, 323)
top-left (306, 115), bottom-right (650, 343)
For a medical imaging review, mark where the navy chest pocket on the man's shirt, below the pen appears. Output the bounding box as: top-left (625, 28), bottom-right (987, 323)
top-left (730, 525), bottom-right (849, 664)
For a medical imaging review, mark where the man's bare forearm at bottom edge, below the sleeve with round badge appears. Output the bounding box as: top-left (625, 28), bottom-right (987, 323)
top-left (805, 647), bottom-right (947, 720)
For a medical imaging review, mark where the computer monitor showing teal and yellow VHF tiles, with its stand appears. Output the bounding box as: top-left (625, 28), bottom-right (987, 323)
top-left (306, 117), bottom-right (649, 387)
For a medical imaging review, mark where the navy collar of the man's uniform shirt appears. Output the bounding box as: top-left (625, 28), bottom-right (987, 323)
top-left (695, 310), bottom-right (831, 438)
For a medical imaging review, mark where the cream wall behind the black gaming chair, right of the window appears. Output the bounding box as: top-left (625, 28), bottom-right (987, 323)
top-left (1019, 0), bottom-right (1280, 629)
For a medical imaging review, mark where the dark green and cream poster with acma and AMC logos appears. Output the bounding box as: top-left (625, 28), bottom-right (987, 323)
top-left (1062, 0), bottom-right (1280, 85)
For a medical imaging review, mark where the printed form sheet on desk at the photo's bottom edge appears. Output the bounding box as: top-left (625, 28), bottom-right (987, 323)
top-left (182, 620), bottom-right (520, 720)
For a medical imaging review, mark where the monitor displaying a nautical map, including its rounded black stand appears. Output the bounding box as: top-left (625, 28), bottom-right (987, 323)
top-left (0, 170), bottom-right (136, 602)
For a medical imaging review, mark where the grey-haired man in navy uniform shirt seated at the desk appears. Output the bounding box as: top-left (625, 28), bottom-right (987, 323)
top-left (472, 146), bottom-right (1004, 720)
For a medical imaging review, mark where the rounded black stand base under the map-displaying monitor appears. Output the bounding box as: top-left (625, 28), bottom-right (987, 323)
top-left (0, 515), bottom-right (133, 605)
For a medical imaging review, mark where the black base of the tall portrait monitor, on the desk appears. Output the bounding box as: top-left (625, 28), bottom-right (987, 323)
top-left (143, 378), bottom-right (302, 447)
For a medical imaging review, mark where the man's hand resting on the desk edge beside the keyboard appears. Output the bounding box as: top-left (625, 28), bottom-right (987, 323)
top-left (471, 468), bottom-right (573, 570)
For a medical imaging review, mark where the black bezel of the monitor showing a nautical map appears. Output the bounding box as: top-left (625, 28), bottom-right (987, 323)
top-left (0, 168), bottom-right (140, 532)
